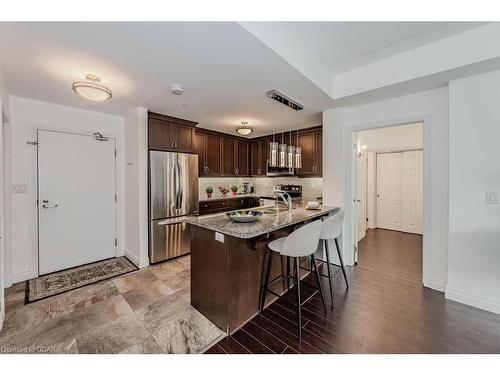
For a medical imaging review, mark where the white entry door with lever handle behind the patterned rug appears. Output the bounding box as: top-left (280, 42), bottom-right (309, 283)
top-left (38, 130), bottom-right (116, 275)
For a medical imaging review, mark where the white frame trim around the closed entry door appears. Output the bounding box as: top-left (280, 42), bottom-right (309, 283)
top-left (28, 129), bottom-right (118, 278)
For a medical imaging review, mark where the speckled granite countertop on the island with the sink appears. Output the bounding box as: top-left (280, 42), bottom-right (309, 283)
top-left (187, 205), bottom-right (339, 239)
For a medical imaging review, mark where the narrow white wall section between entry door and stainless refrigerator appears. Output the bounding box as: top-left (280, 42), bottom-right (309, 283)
top-left (125, 107), bottom-right (149, 268)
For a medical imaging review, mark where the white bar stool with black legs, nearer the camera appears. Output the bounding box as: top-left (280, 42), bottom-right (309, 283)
top-left (260, 220), bottom-right (326, 340)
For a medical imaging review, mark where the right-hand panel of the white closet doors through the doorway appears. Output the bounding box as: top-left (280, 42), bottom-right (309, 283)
top-left (403, 150), bottom-right (424, 234)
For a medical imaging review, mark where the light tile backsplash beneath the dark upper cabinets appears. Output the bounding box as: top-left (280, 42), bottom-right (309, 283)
top-left (198, 177), bottom-right (323, 201)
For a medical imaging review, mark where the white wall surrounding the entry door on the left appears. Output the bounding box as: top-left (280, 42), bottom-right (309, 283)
top-left (10, 96), bottom-right (125, 282)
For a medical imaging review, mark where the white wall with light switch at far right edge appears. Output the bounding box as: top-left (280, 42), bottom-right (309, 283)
top-left (446, 71), bottom-right (500, 313)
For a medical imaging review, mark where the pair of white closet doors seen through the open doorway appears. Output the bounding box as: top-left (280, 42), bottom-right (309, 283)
top-left (377, 150), bottom-right (423, 234)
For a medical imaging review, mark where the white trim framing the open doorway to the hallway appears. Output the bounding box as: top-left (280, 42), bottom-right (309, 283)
top-left (342, 117), bottom-right (436, 289)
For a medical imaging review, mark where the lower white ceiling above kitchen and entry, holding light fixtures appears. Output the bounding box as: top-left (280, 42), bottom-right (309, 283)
top-left (0, 23), bottom-right (332, 136)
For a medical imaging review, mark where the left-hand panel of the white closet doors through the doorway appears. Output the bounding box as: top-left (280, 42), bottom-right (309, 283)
top-left (377, 152), bottom-right (403, 230)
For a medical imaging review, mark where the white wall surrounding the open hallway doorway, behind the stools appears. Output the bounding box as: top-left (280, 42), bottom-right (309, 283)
top-left (323, 88), bottom-right (448, 291)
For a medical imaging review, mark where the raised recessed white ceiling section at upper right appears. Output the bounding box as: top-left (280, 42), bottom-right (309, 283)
top-left (280, 22), bottom-right (485, 74)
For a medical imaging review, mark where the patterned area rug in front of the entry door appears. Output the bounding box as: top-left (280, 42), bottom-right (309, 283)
top-left (25, 257), bottom-right (138, 303)
